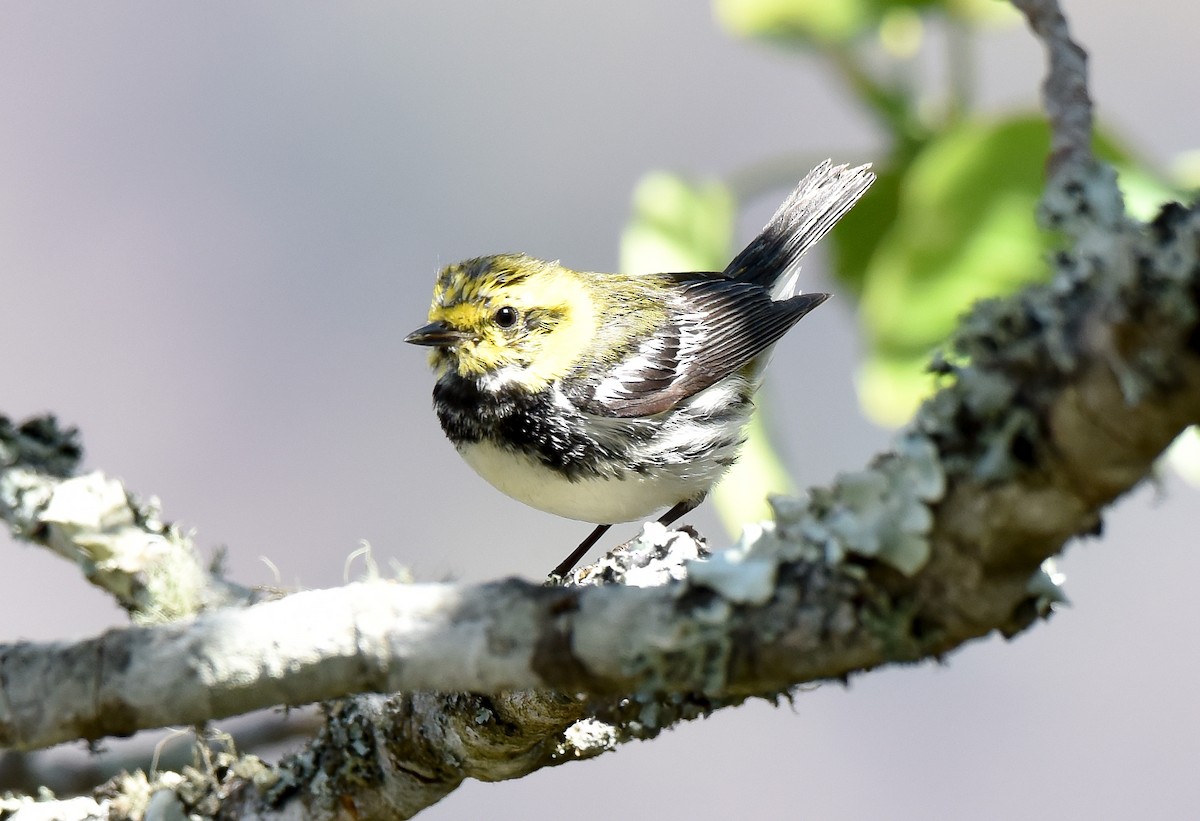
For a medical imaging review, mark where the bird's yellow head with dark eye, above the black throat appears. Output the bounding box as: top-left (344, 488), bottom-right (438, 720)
top-left (420, 254), bottom-right (595, 390)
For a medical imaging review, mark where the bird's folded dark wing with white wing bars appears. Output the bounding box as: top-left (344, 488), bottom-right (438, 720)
top-left (572, 274), bottom-right (829, 418)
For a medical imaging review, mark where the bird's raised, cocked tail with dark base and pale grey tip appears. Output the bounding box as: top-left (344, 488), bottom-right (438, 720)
top-left (725, 160), bottom-right (875, 299)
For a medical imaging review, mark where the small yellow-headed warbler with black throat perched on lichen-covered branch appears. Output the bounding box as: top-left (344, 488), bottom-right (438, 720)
top-left (406, 161), bottom-right (875, 576)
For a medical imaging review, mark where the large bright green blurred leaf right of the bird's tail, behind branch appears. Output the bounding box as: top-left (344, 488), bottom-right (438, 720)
top-left (859, 115), bottom-right (1172, 425)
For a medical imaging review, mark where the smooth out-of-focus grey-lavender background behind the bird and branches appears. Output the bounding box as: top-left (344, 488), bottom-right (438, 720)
top-left (0, 0), bottom-right (1200, 821)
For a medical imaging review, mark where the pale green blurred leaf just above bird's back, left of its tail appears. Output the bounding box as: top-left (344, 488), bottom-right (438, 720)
top-left (620, 172), bottom-right (734, 274)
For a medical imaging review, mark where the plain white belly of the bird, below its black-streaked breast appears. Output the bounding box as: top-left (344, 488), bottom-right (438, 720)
top-left (460, 442), bottom-right (713, 525)
